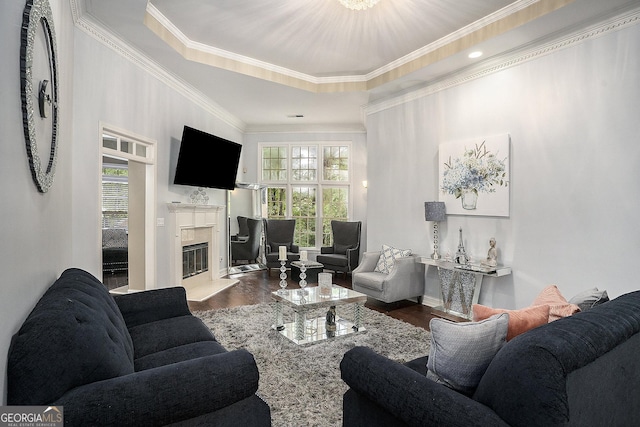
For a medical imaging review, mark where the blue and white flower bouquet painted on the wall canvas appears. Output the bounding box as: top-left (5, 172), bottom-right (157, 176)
top-left (441, 141), bottom-right (509, 199)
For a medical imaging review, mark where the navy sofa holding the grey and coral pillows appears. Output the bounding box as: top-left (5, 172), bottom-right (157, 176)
top-left (340, 291), bottom-right (640, 427)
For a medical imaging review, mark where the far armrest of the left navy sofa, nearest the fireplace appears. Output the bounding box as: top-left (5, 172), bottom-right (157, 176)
top-left (114, 286), bottom-right (191, 328)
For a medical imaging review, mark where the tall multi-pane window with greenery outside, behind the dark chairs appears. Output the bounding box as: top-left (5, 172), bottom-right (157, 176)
top-left (260, 142), bottom-right (351, 248)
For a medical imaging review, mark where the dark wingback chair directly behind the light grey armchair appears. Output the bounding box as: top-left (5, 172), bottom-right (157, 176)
top-left (316, 220), bottom-right (362, 274)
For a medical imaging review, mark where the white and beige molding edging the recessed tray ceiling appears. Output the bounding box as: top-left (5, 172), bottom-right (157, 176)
top-left (144, 0), bottom-right (575, 93)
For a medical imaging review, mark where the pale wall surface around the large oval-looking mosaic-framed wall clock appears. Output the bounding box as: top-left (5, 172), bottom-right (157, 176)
top-left (0, 0), bottom-right (73, 405)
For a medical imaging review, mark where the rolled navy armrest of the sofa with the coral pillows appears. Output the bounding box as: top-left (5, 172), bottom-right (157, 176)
top-left (340, 347), bottom-right (507, 426)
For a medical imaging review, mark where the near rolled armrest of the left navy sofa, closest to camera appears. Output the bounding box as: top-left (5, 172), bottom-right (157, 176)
top-left (53, 350), bottom-right (259, 426)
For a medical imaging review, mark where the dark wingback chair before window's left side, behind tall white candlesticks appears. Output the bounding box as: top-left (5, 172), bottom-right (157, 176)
top-left (263, 219), bottom-right (300, 271)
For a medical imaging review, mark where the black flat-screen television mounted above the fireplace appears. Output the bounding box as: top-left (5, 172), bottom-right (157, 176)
top-left (173, 126), bottom-right (242, 190)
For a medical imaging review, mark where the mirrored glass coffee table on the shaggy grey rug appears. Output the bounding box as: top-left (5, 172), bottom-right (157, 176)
top-left (271, 285), bottom-right (367, 345)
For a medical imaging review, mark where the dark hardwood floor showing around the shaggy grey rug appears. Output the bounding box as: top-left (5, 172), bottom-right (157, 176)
top-left (189, 270), bottom-right (465, 330)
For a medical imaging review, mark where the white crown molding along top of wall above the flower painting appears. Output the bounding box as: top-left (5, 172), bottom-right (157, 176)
top-left (363, 8), bottom-right (640, 116)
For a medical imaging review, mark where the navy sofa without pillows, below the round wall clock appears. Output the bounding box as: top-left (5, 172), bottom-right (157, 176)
top-left (7, 269), bottom-right (271, 426)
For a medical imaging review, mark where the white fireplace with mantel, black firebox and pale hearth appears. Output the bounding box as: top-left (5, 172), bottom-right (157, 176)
top-left (168, 203), bottom-right (237, 301)
